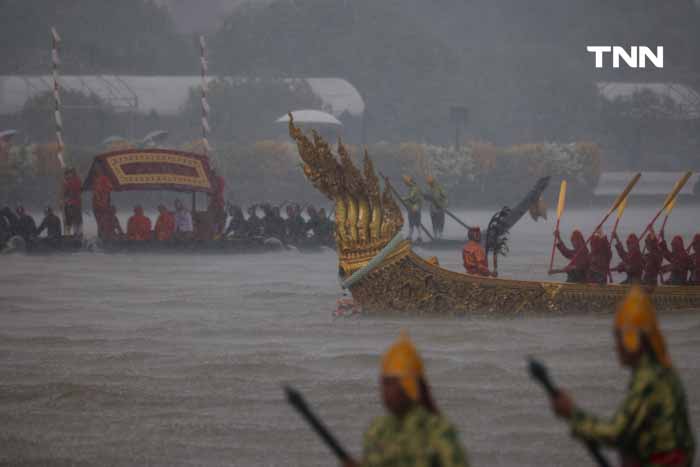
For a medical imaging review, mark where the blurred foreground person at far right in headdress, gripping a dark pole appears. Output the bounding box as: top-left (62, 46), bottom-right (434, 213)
top-left (552, 287), bottom-right (695, 467)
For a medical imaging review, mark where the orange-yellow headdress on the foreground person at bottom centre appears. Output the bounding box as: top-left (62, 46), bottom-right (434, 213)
top-left (382, 333), bottom-right (423, 401)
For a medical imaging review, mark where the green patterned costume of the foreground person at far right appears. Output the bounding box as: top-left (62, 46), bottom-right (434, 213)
top-left (571, 355), bottom-right (695, 466)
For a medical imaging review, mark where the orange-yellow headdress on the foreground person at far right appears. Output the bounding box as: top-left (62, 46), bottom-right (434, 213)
top-left (615, 287), bottom-right (671, 367)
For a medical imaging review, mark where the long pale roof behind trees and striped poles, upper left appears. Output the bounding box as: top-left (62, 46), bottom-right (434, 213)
top-left (0, 75), bottom-right (365, 117)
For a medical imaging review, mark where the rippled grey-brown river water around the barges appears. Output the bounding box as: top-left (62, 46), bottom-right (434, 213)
top-left (0, 206), bottom-right (700, 466)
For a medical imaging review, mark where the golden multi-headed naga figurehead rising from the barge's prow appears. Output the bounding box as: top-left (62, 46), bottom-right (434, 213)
top-left (289, 113), bottom-right (403, 277)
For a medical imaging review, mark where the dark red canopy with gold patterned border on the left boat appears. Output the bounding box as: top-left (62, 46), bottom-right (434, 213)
top-left (83, 149), bottom-right (212, 193)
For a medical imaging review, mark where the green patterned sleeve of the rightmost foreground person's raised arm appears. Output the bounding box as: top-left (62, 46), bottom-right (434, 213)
top-left (570, 374), bottom-right (653, 446)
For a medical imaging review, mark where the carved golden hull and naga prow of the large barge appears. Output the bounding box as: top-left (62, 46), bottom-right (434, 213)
top-left (289, 115), bottom-right (700, 314)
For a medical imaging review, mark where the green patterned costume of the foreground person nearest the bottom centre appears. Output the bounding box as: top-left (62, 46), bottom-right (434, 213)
top-left (361, 405), bottom-right (468, 467)
